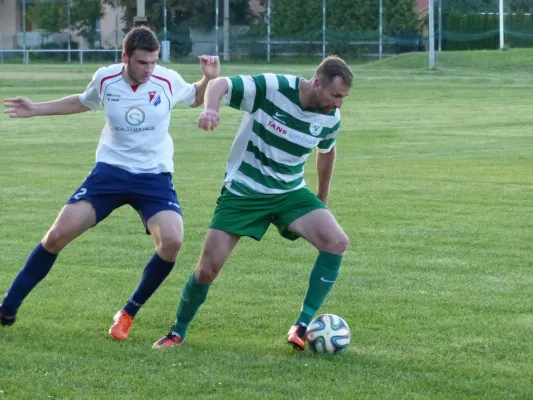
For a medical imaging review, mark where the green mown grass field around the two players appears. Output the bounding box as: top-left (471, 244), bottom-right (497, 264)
top-left (0, 50), bottom-right (533, 400)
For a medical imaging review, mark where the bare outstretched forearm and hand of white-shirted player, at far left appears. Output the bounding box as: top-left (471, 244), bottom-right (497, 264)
top-left (4, 95), bottom-right (90, 118)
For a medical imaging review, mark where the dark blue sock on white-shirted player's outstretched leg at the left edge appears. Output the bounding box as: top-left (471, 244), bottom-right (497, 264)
top-left (2, 243), bottom-right (57, 315)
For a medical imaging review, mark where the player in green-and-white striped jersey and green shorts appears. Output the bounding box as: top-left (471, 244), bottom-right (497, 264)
top-left (154, 56), bottom-right (353, 350)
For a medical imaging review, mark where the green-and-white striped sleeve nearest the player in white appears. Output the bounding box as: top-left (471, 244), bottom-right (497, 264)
top-left (225, 75), bottom-right (267, 113)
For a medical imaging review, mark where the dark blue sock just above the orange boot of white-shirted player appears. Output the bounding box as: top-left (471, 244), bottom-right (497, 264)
top-left (124, 253), bottom-right (176, 317)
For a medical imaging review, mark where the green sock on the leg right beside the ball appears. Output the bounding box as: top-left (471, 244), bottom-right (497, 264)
top-left (296, 251), bottom-right (342, 325)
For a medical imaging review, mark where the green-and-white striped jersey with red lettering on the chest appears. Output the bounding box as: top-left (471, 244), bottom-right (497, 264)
top-left (224, 74), bottom-right (341, 196)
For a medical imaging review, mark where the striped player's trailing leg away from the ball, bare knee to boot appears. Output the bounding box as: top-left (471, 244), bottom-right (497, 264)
top-left (154, 229), bottom-right (240, 349)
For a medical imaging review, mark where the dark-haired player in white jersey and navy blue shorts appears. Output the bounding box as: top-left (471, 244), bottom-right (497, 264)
top-left (0, 27), bottom-right (220, 340)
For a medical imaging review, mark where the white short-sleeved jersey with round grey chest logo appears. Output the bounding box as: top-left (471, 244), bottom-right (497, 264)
top-left (80, 64), bottom-right (196, 173)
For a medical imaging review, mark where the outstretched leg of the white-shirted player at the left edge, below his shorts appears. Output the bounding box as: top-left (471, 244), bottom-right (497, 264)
top-left (0, 200), bottom-right (96, 325)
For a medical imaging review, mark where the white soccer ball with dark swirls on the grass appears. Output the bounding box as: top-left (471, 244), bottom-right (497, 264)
top-left (305, 314), bottom-right (350, 353)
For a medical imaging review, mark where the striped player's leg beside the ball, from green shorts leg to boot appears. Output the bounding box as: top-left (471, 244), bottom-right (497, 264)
top-left (275, 189), bottom-right (348, 350)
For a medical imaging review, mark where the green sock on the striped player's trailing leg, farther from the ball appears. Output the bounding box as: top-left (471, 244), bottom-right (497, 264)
top-left (172, 272), bottom-right (211, 338)
